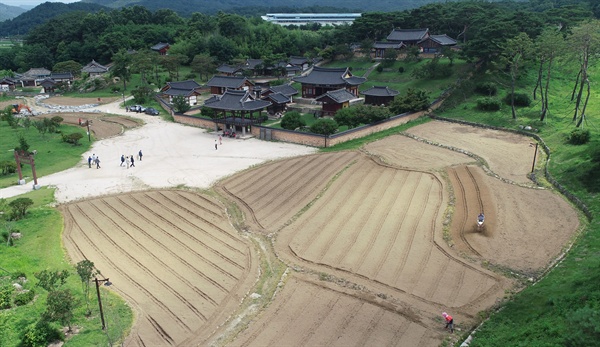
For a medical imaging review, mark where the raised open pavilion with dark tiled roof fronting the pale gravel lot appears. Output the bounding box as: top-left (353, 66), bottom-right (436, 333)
top-left (204, 90), bottom-right (271, 136)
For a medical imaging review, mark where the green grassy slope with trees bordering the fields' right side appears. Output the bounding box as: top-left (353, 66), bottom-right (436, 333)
top-left (438, 59), bottom-right (600, 347)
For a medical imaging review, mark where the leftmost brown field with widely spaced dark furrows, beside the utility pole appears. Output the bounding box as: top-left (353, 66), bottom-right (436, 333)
top-left (62, 191), bottom-right (257, 346)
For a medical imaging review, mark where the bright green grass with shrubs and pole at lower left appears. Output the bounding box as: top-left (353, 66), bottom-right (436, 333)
top-left (0, 189), bottom-right (133, 347)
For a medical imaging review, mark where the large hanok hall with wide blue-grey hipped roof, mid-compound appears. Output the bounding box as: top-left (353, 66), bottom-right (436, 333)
top-left (292, 66), bottom-right (367, 98)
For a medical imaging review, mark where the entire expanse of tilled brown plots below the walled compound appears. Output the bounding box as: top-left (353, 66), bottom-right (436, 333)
top-left (63, 122), bottom-right (579, 346)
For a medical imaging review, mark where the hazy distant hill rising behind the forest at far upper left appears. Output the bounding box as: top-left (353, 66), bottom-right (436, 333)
top-left (0, 2), bottom-right (107, 37)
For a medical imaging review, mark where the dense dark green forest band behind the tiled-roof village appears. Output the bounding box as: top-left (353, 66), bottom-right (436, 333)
top-left (0, 1), bottom-right (594, 72)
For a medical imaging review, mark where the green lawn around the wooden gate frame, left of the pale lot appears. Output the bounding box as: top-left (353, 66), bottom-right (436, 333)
top-left (0, 121), bottom-right (91, 188)
